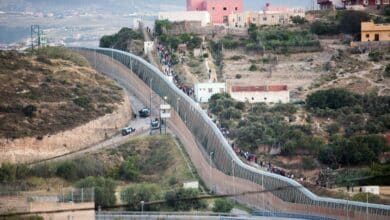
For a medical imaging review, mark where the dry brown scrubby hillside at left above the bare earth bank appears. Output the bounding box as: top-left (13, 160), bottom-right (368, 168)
top-left (0, 48), bottom-right (123, 139)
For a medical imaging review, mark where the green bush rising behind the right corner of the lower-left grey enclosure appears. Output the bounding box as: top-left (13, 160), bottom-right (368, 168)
top-left (75, 176), bottom-right (116, 208)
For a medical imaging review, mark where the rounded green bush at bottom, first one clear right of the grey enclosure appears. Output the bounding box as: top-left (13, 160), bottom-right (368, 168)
top-left (121, 183), bottom-right (160, 211)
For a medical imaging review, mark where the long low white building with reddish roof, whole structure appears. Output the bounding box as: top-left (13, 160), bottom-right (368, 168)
top-left (228, 85), bottom-right (290, 103)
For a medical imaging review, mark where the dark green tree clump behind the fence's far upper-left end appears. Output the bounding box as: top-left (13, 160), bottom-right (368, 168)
top-left (99, 28), bottom-right (143, 51)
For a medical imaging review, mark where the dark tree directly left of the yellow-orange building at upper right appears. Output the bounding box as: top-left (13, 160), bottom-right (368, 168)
top-left (337, 10), bottom-right (370, 35)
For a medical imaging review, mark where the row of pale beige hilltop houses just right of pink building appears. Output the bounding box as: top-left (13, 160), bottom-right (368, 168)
top-left (229, 3), bottom-right (305, 28)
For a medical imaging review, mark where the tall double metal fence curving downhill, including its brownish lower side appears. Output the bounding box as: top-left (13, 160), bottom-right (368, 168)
top-left (71, 48), bottom-right (390, 219)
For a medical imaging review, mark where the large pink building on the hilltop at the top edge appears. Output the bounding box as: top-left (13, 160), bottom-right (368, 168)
top-left (187, 0), bottom-right (244, 24)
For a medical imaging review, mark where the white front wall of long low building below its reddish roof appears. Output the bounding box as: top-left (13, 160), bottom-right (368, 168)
top-left (230, 91), bottom-right (290, 103)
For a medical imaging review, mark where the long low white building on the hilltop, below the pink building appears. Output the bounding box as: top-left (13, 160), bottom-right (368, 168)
top-left (158, 11), bottom-right (211, 27)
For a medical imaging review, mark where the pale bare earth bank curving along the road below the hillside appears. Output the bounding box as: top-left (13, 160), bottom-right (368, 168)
top-left (0, 91), bottom-right (132, 163)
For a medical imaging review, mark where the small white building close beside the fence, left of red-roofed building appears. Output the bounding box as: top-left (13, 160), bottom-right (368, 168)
top-left (194, 83), bottom-right (226, 103)
